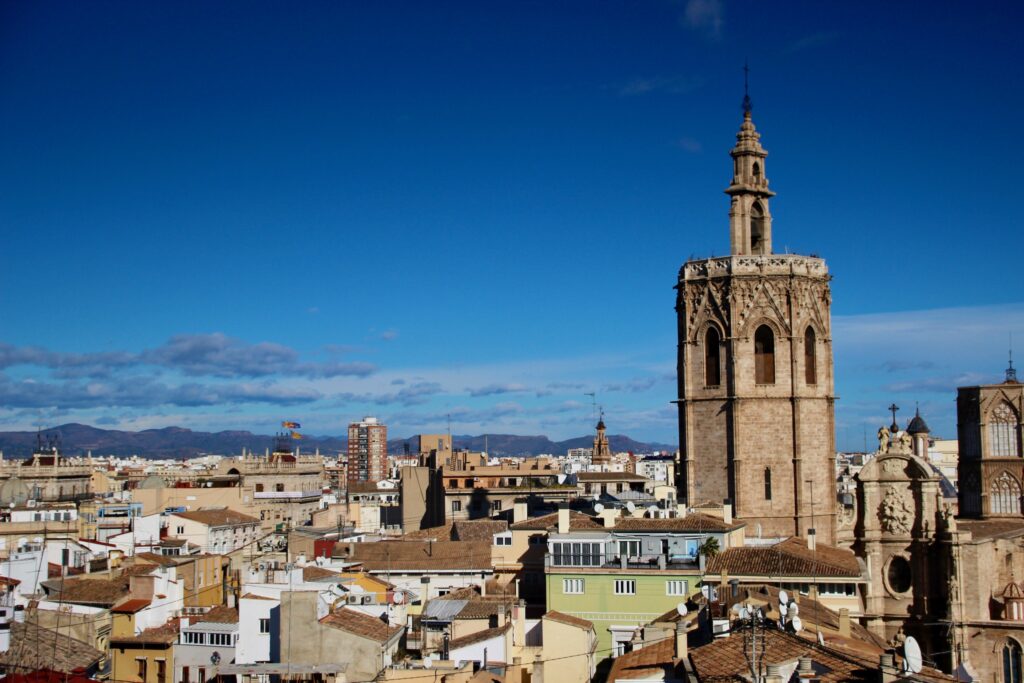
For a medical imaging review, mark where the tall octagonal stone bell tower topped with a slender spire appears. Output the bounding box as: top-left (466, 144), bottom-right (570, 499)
top-left (676, 97), bottom-right (836, 544)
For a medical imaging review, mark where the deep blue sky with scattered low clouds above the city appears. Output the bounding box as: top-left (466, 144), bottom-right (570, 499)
top-left (0, 0), bottom-right (1024, 447)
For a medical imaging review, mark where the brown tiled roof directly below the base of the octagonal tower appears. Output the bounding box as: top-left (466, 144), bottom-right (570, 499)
top-left (707, 537), bottom-right (861, 579)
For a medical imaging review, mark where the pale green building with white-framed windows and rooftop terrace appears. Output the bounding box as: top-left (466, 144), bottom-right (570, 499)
top-left (544, 510), bottom-right (743, 659)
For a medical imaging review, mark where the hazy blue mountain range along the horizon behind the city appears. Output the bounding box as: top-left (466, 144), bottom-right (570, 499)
top-left (0, 423), bottom-right (676, 459)
